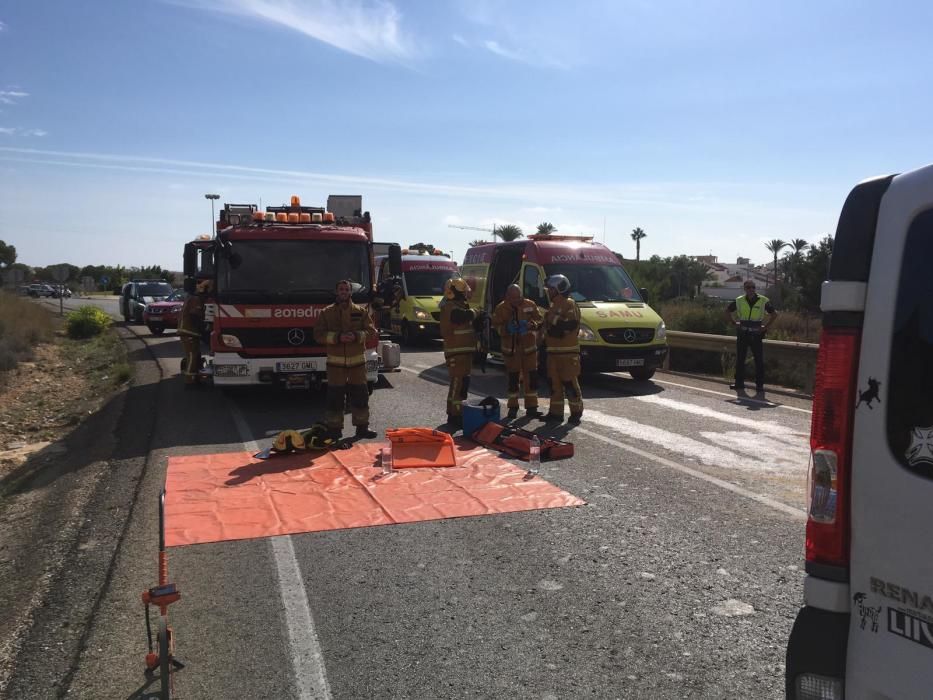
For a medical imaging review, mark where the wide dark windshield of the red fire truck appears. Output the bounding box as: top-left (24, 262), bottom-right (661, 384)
top-left (217, 240), bottom-right (371, 303)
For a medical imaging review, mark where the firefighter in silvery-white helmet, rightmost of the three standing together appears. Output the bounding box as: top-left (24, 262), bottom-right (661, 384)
top-left (544, 275), bottom-right (583, 423)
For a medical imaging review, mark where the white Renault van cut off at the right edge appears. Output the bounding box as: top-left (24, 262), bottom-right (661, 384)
top-left (786, 166), bottom-right (933, 700)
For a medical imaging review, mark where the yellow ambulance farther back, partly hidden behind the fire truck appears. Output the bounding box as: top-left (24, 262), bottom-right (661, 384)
top-left (376, 244), bottom-right (460, 345)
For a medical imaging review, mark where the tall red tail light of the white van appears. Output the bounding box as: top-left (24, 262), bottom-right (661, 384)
top-left (807, 327), bottom-right (861, 566)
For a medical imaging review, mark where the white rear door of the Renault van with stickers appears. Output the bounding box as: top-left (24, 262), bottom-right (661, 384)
top-left (846, 166), bottom-right (933, 698)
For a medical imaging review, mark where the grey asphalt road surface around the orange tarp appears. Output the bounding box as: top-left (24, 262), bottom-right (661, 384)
top-left (7, 300), bottom-right (810, 698)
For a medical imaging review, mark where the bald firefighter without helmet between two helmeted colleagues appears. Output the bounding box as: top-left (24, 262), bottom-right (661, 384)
top-left (492, 284), bottom-right (543, 418)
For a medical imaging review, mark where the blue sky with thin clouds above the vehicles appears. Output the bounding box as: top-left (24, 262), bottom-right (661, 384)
top-left (0, 0), bottom-right (933, 269)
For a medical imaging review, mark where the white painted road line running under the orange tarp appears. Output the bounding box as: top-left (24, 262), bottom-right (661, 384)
top-left (230, 404), bottom-right (331, 700)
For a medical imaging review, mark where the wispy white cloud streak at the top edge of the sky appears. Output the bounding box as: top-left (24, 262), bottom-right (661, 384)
top-left (177, 0), bottom-right (417, 63)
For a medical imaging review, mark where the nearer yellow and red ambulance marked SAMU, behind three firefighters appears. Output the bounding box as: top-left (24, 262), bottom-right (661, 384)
top-left (461, 234), bottom-right (667, 380)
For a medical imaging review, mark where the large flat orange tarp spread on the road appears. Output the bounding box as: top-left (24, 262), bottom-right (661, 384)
top-left (165, 441), bottom-right (584, 547)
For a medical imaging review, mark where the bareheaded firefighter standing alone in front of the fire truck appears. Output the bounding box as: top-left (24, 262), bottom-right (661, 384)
top-left (314, 280), bottom-right (376, 440)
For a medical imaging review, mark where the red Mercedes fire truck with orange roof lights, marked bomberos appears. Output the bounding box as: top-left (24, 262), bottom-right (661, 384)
top-left (184, 195), bottom-right (401, 390)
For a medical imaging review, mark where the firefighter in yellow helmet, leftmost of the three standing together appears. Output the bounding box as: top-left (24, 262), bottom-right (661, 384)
top-left (440, 277), bottom-right (477, 427)
